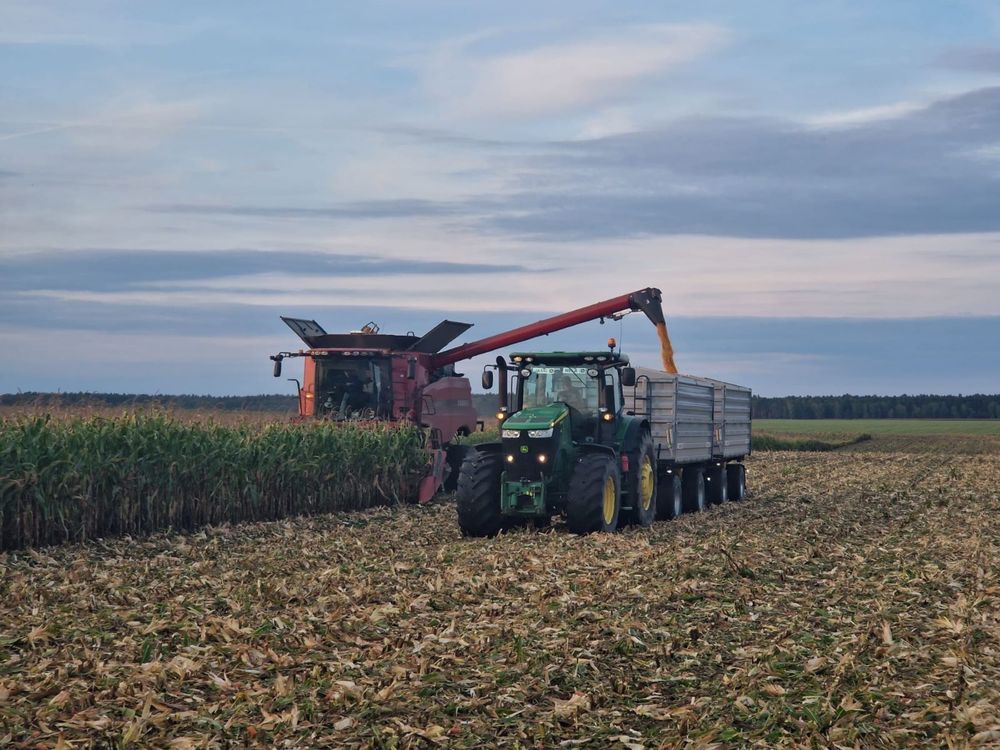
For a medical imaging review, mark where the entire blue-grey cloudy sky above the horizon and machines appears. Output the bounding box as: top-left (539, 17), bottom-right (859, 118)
top-left (0, 0), bottom-right (1000, 395)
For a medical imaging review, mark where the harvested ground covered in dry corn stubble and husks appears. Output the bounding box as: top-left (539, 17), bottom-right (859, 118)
top-left (0, 452), bottom-right (1000, 748)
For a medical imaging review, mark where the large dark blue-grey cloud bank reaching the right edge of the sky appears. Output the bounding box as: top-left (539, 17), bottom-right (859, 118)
top-left (472, 87), bottom-right (1000, 241)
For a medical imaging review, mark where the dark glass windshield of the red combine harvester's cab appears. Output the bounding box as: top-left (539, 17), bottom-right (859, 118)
top-left (316, 356), bottom-right (390, 419)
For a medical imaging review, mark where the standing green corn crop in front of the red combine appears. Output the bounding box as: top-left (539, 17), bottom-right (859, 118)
top-left (0, 413), bottom-right (425, 549)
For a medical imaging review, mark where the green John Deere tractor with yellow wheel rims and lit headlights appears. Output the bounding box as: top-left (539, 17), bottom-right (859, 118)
top-left (457, 349), bottom-right (668, 536)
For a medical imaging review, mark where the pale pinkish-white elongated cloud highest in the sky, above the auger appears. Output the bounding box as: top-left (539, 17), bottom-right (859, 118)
top-left (421, 24), bottom-right (726, 118)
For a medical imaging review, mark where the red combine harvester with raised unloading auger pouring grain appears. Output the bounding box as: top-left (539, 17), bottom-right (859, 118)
top-left (271, 288), bottom-right (665, 503)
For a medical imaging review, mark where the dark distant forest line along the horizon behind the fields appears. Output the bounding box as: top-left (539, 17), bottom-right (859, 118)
top-left (0, 392), bottom-right (1000, 419)
